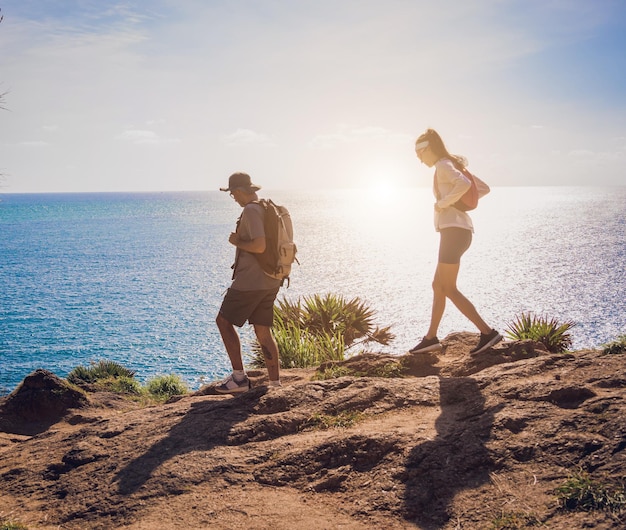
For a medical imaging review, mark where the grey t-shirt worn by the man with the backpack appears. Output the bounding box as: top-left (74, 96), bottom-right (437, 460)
top-left (230, 204), bottom-right (281, 291)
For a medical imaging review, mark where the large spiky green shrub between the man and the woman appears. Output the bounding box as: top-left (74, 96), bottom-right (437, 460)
top-left (247, 294), bottom-right (394, 368)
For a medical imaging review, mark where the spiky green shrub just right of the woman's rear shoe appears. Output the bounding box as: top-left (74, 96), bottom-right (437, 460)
top-left (505, 313), bottom-right (576, 353)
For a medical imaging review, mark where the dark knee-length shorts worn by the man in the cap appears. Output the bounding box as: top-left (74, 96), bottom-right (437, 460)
top-left (220, 289), bottom-right (278, 327)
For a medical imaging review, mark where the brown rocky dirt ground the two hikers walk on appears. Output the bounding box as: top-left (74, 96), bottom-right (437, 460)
top-left (0, 333), bottom-right (626, 530)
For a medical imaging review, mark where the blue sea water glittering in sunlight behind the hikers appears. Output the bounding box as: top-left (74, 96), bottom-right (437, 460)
top-left (0, 187), bottom-right (626, 395)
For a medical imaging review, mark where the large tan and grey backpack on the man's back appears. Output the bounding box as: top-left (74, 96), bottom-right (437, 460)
top-left (254, 199), bottom-right (300, 285)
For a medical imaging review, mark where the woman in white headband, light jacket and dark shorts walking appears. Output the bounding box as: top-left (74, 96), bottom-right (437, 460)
top-left (410, 129), bottom-right (502, 353)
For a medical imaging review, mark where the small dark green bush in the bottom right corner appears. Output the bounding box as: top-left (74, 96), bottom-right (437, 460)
top-left (556, 471), bottom-right (626, 512)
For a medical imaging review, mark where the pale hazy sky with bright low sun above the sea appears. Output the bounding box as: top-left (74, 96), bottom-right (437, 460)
top-left (0, 0), bottom-right (626, 193)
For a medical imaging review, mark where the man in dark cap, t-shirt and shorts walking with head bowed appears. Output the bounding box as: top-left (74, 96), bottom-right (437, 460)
top-left (216, 173), bottom-right (281, 394)
